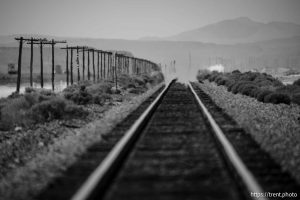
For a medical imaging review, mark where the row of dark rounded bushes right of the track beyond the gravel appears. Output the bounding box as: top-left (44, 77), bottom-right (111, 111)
top-left (197, 70), bottom-right (300, 105)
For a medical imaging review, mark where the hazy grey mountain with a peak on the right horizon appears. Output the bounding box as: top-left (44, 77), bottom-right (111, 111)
top-left (146, 17), bottom-right (300, 44)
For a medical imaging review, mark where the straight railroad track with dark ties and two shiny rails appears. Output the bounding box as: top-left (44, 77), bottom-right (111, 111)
top-left (38, 81), bottom-right (299, 200)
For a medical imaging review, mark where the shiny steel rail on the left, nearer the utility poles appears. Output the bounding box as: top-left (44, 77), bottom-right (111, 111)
top-left (71, 79), bottom-right (174, 200)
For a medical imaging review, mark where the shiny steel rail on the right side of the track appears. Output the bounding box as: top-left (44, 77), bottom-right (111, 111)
top-left (188, 82), bottom-right (268, 200)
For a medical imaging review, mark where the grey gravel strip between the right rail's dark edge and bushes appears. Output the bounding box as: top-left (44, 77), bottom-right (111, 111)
top-left (198, 81), bottom-right (300, 183)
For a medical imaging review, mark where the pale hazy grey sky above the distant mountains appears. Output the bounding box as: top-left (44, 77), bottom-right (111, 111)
top-left (0, 0), bottom-right (300, 39)
